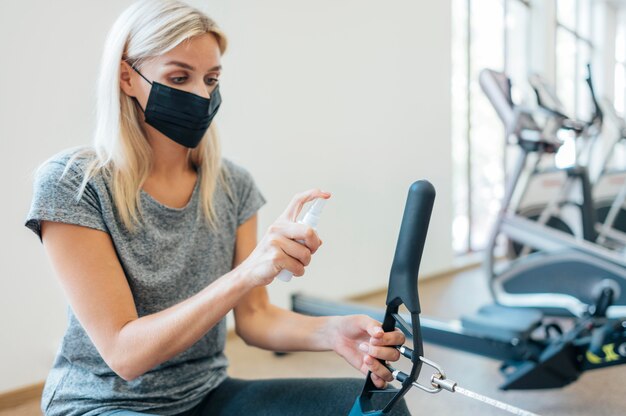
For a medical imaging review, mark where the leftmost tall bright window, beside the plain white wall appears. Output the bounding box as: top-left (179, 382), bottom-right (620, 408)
top-left (452, 0), bottom-right (530, 253)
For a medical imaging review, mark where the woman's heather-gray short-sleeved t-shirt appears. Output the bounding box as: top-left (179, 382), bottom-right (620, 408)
top-left (25, 149), bottom-right (265, 416)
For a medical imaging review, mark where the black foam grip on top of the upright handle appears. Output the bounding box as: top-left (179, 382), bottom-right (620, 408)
top-left (387, 180), bottom-right (435, 313)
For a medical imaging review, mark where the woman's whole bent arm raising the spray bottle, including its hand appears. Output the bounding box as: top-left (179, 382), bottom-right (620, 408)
top-left (41, 190), bottom-right (328, 380)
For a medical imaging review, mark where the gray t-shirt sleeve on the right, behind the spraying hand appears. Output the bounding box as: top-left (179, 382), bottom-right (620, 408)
top-left (226, 162), bottom-right (267, 226)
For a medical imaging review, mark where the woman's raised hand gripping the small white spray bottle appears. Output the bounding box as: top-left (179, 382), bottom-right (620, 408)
top-left (237, 189), bottom-right (330, 286)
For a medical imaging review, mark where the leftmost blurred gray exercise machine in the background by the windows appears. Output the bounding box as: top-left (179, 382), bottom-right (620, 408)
top-left (480, 69), bottom-right (626, 317)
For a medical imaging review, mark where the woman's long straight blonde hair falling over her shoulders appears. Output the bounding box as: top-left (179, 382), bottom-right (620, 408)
top-left (64, 0), bottom-right (227, 231)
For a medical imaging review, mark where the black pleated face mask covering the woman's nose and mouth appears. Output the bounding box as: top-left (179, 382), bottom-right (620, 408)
top-left (133, 67), bottom-right (222, 149)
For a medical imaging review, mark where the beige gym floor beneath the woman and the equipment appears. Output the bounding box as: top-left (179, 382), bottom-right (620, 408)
top-left (0, 269), bottom-right (626, 416)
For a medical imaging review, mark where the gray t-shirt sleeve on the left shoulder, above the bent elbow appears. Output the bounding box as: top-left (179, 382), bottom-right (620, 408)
top-left (24, 161), bottom-right (108, 241)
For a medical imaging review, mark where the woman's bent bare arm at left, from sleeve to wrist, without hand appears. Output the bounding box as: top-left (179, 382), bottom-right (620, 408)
top-left (42, 221), bottom-right (254, 380)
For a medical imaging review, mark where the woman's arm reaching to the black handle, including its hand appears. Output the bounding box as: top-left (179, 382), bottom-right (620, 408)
top-left (230, 215), bottom-right (405, 388)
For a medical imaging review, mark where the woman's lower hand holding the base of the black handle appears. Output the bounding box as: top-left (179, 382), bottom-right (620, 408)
top-left (329, 315), bottom-right (406, 388)
